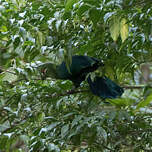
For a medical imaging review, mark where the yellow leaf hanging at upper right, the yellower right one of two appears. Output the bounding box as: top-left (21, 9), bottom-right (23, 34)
top-left (120, 18), bottom-right (129, 42)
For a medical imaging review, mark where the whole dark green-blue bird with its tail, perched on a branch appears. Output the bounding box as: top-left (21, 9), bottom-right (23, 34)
top-left (39, 55), bottom-right (123, 98)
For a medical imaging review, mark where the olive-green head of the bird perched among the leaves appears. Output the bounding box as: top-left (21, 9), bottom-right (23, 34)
top-left (38, 63), bottom-right (57, 80)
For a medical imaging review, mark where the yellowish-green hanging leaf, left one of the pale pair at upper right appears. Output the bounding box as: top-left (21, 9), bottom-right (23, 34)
top-left (109, 15), bottom-right (120, 41)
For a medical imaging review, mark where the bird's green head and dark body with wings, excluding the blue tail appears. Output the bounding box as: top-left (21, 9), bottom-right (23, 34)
top-left (39, 55), bottom-right (104, 88)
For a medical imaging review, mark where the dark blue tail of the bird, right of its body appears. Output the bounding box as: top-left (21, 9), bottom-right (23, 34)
top-left (87, 76), bottom-right (124, 99)
